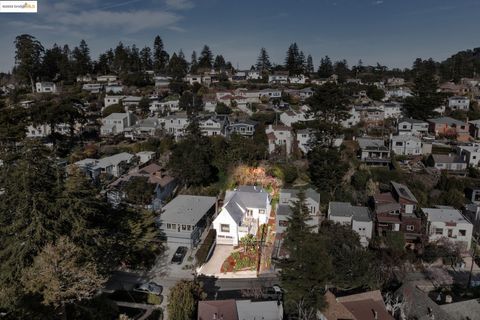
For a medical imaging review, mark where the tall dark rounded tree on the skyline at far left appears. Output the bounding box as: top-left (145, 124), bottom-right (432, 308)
top-left (15, 34), bottom-right (44, 93)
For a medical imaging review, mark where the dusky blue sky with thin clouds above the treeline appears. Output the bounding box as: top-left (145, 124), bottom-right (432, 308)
top-left (0, 0), bottom-right (480, 71)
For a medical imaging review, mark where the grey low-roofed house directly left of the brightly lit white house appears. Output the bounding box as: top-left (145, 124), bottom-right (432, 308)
top-left (156, 195), bottom-right (217, 248)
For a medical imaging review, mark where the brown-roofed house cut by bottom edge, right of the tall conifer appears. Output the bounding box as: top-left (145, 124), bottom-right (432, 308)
top-left (318, 290), bottom-right (395, 320)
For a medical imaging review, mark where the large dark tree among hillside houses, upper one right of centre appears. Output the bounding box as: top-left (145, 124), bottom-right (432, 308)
top-left (307, 82), bottom-right (349, 147)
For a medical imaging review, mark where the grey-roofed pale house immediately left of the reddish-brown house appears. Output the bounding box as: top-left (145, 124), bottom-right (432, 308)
top-left (327, 202), bottom-right (373, 247)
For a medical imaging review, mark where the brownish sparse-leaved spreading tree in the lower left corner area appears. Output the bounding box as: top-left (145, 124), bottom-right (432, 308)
top-left (22, 237), bottom-right (105, 307)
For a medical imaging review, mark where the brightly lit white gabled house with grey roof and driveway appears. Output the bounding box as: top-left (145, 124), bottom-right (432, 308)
top-left (213, 186), bottom-right (272, 246)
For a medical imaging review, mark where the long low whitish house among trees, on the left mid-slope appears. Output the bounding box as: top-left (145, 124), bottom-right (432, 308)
top-left (74, 152), bottom-right (134, 180)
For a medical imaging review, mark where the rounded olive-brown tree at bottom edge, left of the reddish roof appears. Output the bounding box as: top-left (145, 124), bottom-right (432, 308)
top-left (167, 280), bottom-right (205, 320)
